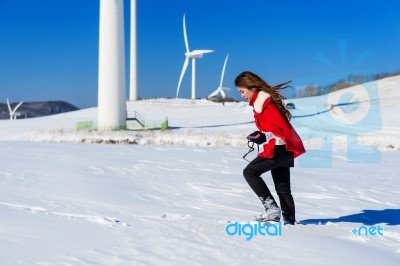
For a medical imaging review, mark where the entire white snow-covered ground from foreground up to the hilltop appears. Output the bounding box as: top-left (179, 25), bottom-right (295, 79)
top-left (0, 76), bottom-right (400, 266)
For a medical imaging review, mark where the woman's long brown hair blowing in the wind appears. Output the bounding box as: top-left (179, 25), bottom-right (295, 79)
top-left (235, 71), bottom-right (292, 121)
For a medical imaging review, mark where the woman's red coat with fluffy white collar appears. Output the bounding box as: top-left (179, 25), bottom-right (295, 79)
top-left (249, 91), bottom-right (306, 158)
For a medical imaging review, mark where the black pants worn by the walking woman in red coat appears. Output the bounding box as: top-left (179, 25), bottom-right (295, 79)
top-left (243, 145), bottom-right (295, 219)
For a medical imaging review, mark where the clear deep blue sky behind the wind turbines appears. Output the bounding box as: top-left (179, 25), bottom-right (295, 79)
top-left (0, 0), bottom-right (400, 108)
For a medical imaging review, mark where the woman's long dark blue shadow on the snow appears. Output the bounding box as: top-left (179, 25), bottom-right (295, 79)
top-left (300, 209), bottom-right (400, 225)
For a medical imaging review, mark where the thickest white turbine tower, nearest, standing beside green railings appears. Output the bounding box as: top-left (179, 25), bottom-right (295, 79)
top-left (97, 0), bottom-right (126, 130)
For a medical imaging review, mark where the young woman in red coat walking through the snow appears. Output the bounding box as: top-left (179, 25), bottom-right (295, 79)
top-left (235, 71), bottom-right (305, 224)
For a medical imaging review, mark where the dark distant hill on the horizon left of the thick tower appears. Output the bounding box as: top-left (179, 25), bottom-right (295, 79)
top-left (0, 101), bottom-right (79, 119)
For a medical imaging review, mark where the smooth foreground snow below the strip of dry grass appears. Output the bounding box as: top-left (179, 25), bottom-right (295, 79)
top-left (0, 142), bottom-right (400, 265)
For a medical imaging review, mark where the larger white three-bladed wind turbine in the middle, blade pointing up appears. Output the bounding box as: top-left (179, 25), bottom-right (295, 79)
top-left (176, 15), bottom-right (215, 100)
